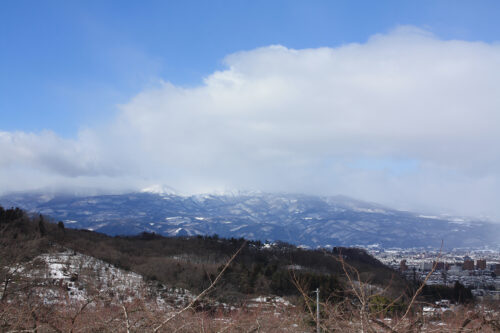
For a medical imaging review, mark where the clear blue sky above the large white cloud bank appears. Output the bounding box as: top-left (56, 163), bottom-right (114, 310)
top-left (0, 0), bottom-right (500, 137)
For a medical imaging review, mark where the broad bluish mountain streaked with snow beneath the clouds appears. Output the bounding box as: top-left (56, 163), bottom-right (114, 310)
top-left (0, 191), bottom-right (500, 248)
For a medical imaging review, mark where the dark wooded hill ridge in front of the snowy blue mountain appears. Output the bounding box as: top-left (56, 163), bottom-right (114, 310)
top-left (0, 207), bottom-right (463, 302)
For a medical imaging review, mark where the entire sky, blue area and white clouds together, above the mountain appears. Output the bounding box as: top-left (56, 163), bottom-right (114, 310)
top-left (0, 0), bottom-right (500, 221)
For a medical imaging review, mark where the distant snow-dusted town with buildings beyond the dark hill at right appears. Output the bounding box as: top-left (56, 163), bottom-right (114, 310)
top-left (367, 248), bottom-right (500, 300)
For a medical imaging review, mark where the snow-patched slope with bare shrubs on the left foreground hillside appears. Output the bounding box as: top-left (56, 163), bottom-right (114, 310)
top-left (9, 250), bottom-right (194, 310)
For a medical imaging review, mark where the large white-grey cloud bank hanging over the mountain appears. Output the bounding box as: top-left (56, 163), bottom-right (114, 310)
top-left (0, 27), bottom-right (500, 217)
